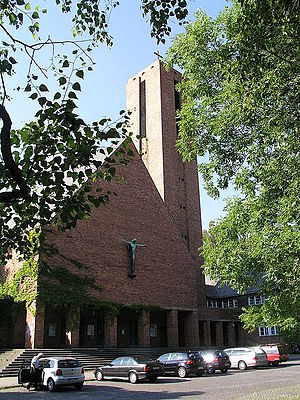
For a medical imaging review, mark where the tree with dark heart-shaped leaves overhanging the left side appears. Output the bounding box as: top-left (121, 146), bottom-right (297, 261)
top-left (0, 0), bottom-right (187, 263)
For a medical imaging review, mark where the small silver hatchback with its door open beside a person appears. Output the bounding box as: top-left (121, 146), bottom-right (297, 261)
top-left (18, 357), bottom-right (85, 392)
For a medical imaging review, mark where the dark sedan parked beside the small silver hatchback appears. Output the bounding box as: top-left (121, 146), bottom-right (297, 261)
top-left (95, 356), bottom-right (164, 383)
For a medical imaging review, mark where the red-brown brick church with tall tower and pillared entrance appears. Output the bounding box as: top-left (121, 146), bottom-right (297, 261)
top-left (1, 60), bottom-right (278, 348)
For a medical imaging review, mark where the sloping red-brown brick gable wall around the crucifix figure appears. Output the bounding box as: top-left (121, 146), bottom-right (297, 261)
top-left (42, 147), bottom-right (197, 309)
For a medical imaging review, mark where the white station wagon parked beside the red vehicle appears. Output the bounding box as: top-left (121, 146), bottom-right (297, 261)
top-left (224, 347), bottom-right (269, 370)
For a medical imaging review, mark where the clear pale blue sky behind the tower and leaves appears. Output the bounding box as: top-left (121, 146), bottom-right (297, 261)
top-left (0, 0), bottom-right (232, 229)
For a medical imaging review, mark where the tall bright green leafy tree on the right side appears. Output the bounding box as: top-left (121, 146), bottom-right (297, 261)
top-left (167, 0), bottom-right (300, 331)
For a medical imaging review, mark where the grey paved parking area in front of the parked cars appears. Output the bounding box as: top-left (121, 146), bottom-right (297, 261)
top-left (0, 360), bottom-right (300, 400)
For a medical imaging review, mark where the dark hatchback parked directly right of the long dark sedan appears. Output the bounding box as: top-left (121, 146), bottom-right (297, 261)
top-left (157, 352), bottom-right (205, 378)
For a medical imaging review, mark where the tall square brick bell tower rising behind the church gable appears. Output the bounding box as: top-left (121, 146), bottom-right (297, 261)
top-left (126, 60), bottom-right (202, 258)
